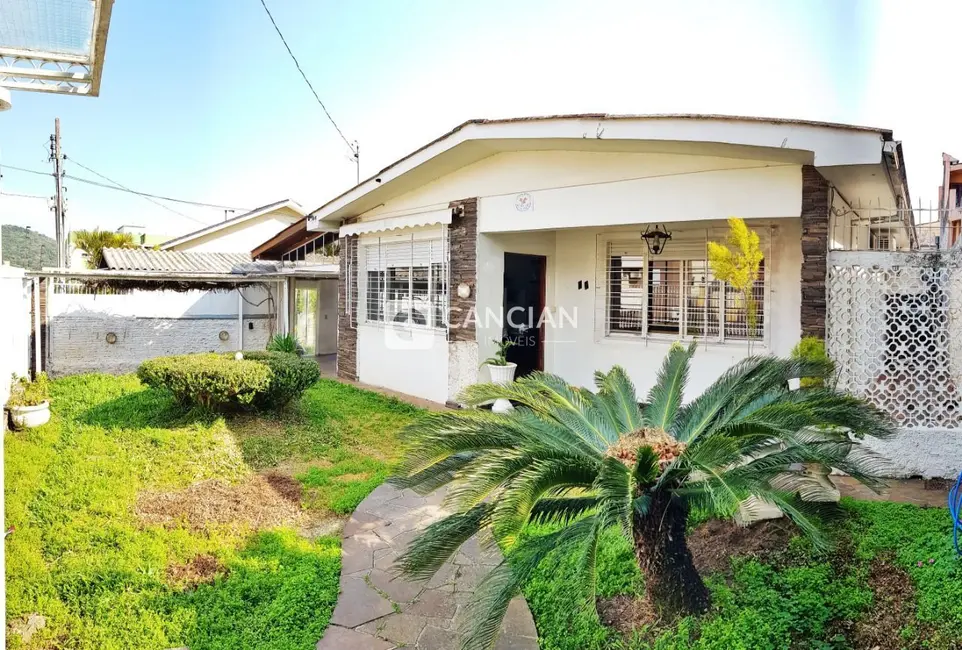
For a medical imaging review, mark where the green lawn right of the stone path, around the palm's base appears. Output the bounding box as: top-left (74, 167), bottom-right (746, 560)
top-left (524, 499), bottom-right (962, 650)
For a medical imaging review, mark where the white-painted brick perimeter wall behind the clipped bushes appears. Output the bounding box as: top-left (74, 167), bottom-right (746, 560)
top-left (47, 286), bottom-right (280, 376)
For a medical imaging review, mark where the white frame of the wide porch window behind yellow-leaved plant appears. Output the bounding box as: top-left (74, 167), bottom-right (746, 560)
top-left (595, 228), bottom-right (775, 347)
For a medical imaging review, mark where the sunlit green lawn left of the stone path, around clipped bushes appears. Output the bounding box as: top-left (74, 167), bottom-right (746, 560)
top-left (4, 375), bottom-right (418, 650)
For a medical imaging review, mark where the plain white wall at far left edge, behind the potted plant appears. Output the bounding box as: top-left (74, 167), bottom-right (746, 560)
top-left (0, 265), bottom-right (32, 407)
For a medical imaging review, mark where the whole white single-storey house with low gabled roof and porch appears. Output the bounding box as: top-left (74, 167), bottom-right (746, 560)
top-left (308, 115), bottom-right (913, 402)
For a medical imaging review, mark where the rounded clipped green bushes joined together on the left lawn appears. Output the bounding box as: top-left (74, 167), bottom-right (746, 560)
top-left (137, 352), bottom-right (320, 410)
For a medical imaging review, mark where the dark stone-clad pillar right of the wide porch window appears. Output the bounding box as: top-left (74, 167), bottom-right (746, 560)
top-left (801, 165), bottom-right (829, 339)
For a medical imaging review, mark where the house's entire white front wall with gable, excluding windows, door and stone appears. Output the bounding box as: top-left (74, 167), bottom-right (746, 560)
top-left (348, 151), bottom-right (802, 401)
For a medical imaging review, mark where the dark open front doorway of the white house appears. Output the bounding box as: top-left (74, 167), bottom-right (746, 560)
top-left (504, 253), bottom-right (545, 377)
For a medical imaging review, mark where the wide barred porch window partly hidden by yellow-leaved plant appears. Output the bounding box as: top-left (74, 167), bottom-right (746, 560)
top-left (605, 242), bottom-right (766, 340)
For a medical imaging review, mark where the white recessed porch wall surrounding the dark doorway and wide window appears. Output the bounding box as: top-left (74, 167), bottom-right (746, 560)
top-left (478, 220), bottom-right (802, 398)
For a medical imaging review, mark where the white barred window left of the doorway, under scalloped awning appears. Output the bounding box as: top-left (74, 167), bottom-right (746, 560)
top-left (361, 236), bottom-right (448, 328)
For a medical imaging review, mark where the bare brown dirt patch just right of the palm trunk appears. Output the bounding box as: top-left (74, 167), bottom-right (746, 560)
top-left (688, 519), bottom-right (798, 575)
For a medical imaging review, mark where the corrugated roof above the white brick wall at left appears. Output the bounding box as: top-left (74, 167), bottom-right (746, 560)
top-left (104, 248), bottom-right (280, 275)
